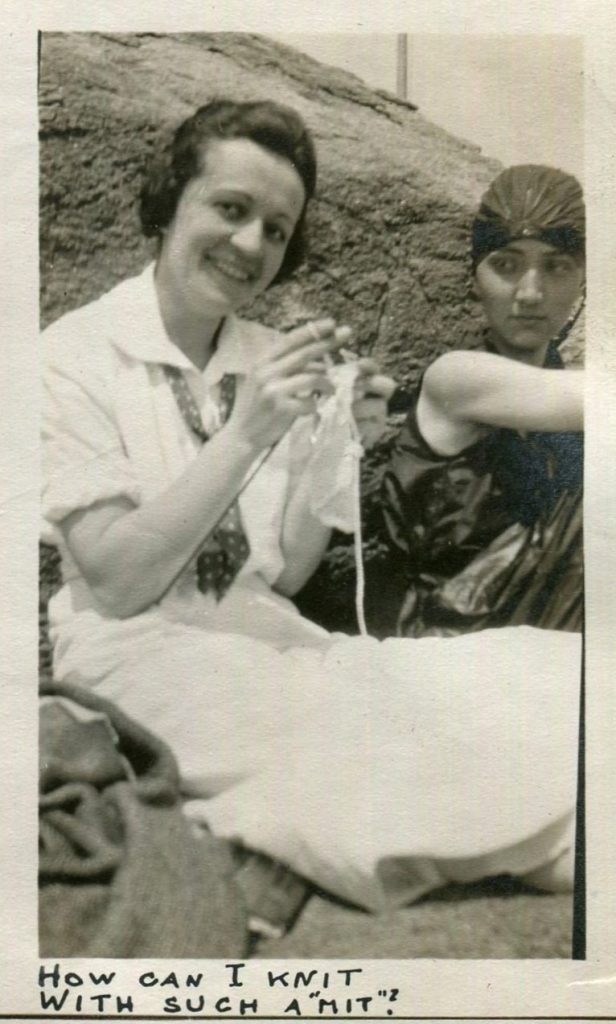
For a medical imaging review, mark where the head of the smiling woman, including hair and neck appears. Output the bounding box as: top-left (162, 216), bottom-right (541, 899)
top-left (140, 100), bottom-right (316, 369)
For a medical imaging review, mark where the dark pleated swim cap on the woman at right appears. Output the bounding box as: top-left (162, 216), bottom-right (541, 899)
top-left (472, 164), bottom-right (586, 269)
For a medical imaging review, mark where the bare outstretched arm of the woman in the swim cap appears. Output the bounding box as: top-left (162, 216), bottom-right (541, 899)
top-left (419, 351), bottom-right (584, 451)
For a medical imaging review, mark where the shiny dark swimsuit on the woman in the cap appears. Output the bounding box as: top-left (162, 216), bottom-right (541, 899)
top-left (376, 346), bottom-right (583, 637)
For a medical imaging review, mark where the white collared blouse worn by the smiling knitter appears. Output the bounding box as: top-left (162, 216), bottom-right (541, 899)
top-left (43, 264), bottom-right (331, 671)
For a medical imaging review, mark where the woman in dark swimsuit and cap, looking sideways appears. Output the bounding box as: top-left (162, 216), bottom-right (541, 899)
top-left (375, 165), bottom-right (585, 637)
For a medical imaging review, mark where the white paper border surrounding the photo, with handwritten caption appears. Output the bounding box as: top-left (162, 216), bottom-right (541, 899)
top-left (0, 0), bottom-right (616, 1021)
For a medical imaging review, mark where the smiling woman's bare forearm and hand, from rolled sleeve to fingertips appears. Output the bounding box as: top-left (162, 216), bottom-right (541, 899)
top-left (60, 322), bottom-right (346, 617)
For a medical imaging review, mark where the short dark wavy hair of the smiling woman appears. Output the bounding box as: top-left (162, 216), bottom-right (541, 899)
top-left (139, 99), bottom-right (316, 285)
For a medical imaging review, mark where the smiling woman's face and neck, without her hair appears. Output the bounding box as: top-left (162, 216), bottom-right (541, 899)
top-left (152, 138), bottom-right (306, 369)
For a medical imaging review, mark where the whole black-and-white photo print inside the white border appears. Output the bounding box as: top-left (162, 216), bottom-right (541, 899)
top-left (38, 31), bottom-right (586, 961)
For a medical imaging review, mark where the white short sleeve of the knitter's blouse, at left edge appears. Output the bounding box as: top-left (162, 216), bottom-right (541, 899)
top-left (42, 314), bottom-right (139, 523)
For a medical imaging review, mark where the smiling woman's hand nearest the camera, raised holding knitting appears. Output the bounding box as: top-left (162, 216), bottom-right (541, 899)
top-left (227, 319), bottom-right (351, 452)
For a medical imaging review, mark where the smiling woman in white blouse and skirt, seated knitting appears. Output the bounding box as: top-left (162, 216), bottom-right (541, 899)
top-left (44, 100), bottom-right (579, 907)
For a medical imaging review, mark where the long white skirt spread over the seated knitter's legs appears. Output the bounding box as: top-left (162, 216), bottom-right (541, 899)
top-left (50, 587), bottom-right (581, 909)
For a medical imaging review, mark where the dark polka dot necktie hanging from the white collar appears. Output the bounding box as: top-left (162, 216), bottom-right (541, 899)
top-left (164, 366), bottom-right (251, 601)
